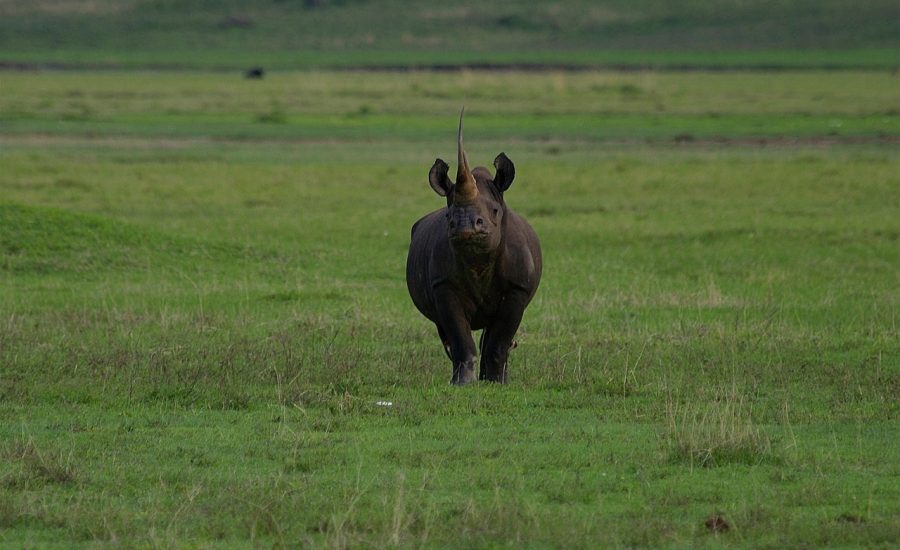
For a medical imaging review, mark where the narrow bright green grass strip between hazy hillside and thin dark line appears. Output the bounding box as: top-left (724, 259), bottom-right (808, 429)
top-left (0, 46), bottom-right (900, 73)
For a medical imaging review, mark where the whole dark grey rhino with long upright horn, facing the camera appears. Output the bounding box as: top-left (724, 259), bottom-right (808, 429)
top-left (406, 108), bottom-right (542, 384)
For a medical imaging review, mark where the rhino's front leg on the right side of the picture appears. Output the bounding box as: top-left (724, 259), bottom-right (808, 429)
top-left (479, 289), bottom-right (530, 383)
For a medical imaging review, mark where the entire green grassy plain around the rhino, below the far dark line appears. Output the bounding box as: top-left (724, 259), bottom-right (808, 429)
top-left (0, 68), bottom-right (900, 548)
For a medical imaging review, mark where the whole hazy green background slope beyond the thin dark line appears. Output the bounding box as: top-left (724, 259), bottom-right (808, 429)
top-left (0, 0), bottom-right (900, 69)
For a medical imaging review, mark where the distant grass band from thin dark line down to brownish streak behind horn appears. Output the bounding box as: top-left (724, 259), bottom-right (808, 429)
top-left (0, 71), bottom-right (900, 143)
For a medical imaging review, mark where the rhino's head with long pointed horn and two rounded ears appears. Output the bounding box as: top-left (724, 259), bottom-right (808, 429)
top-left (428, 113), bottom-right (516, 260)
